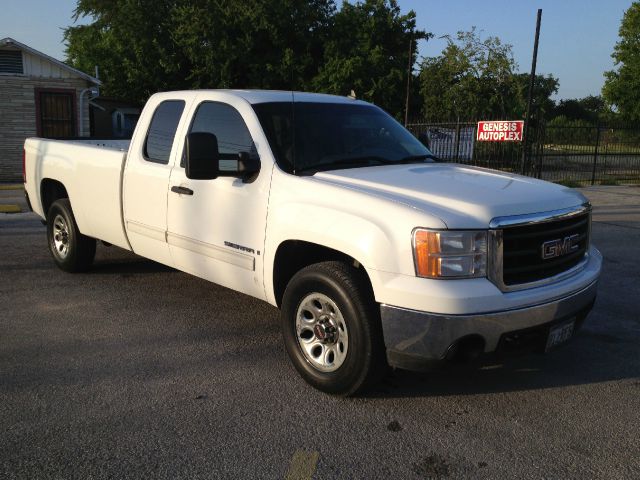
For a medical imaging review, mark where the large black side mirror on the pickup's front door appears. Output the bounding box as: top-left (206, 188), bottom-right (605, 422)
top-left (185, 132), bottom-right (260, 183)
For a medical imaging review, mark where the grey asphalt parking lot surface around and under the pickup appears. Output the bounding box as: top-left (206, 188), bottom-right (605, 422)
top-left (0, 187), bottom-right (640, 479)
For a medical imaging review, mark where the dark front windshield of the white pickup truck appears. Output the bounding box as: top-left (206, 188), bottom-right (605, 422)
top-left (253, 102), bottom-right (434, 174)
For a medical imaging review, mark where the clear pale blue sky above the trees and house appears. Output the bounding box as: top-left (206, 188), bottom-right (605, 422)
top-left (0, 0), bottom-right (632, 99)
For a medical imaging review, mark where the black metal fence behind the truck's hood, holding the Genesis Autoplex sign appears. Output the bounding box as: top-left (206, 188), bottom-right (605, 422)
top-left (407, 122), bottom-right (640, 186)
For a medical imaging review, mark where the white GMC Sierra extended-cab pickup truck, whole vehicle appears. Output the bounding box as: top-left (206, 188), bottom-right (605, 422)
top-left (25, 90), bottom-right (602, 395)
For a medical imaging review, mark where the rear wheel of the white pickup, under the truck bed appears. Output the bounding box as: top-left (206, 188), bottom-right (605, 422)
top-left (47, 198), bottom-right (96, 272)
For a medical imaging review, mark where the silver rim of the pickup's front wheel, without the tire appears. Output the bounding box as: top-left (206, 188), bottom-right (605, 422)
top-left (296, 292), bottom-right (349, 372)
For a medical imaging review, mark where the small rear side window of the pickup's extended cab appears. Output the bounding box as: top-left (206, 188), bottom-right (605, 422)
top-left (144, 100), bottom-right (184, 165)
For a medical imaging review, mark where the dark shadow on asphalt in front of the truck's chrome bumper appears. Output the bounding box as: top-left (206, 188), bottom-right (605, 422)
top-left (368, 328), bottom-right (640, 398)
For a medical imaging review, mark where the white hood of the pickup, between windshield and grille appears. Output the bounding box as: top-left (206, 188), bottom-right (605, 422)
top-left (313, 163), bottom-right (587, 228)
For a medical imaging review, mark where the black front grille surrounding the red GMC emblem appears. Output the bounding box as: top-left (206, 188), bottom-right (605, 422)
top-left (502, 212), bottom-right (589, 286)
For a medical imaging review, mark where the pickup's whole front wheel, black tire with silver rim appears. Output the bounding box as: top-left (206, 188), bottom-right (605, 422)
top-left (281, 262), bottom-right (387, 396)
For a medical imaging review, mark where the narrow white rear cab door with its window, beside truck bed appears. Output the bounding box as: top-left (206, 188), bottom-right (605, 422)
top-left (123, 95), bottom-right (188, 265)
